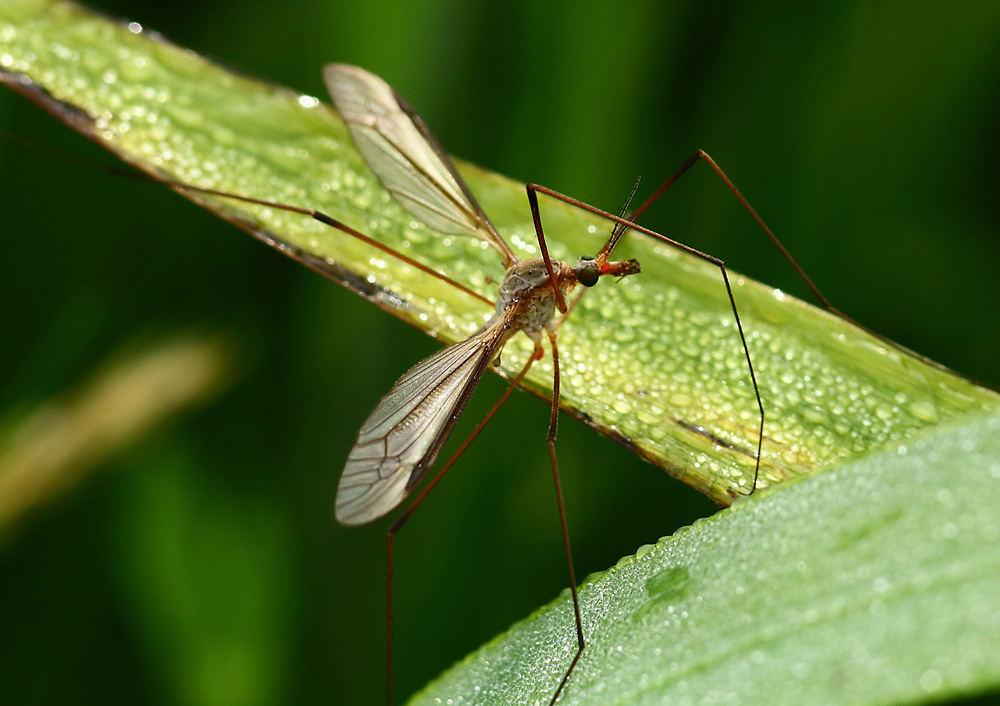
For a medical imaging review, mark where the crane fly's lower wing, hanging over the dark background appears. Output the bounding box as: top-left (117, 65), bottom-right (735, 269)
top-left (336, 319), bottom-right (508, 525)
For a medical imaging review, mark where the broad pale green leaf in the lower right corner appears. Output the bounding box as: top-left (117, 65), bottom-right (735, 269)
top-left (410, 413), bottom-right (1000, 706)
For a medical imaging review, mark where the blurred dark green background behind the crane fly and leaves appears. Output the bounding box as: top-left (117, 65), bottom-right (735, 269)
top-left (0, 0), bottom-right (1000, 705)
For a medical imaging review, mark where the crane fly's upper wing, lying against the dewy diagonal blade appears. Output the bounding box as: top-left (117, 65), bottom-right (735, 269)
top-left (323, 64), bottom-right (517, 267)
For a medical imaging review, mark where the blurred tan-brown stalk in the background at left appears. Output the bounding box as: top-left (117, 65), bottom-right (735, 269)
top-left (0, 332), bottom-right (238, 539)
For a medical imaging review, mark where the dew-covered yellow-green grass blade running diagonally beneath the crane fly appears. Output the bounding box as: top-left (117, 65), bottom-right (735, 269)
top-left (0, 0), bottom-right (1000, 504)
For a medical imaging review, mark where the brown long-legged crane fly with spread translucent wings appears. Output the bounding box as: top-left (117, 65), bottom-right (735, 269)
top-left (323, 64), bottom-right (764, 706)
